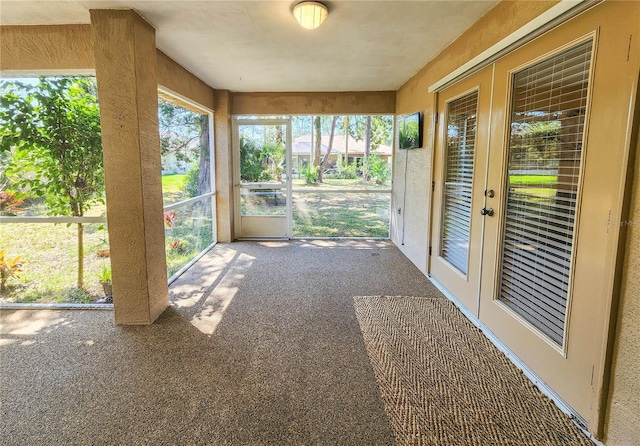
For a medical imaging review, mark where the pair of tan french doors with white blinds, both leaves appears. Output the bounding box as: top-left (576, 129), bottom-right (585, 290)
top-left (430, 5), bottom-right (637, 432)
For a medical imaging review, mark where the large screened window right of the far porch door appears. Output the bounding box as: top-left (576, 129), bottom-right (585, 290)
top-left (292, 115), bottom-right (393, 238)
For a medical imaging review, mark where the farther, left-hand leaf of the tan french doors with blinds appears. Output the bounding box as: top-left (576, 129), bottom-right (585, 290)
top-left (430, 68), bottom-right (491, 316)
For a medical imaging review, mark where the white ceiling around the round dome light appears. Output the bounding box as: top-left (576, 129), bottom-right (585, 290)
top-left (0, 0), bottom-right (497, 92)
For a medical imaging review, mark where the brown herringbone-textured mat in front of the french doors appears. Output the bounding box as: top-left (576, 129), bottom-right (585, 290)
top-left (354, 296), bottom-right (592, 446)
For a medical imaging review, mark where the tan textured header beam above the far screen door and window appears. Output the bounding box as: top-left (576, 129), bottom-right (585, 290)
top-left (231, 91), bottom-right (396, 116)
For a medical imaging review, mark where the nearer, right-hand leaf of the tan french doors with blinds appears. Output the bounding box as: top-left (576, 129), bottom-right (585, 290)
top-left (480, 5), bottom-right (633, 431)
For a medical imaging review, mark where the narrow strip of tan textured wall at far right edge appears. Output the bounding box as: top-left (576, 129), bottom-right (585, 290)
top-left (605, 127), bottom-right (640, 446)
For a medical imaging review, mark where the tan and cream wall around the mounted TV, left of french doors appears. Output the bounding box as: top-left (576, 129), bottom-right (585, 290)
top-left (391, 1), bottom-right (557, 274)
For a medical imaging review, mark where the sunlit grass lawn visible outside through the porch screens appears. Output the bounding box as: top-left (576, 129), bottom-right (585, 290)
top-left (0, 175), bottom-right (390, 303)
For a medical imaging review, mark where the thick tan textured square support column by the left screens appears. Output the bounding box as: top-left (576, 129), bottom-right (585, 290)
top-left (91, 10), bottom-right (169, 324)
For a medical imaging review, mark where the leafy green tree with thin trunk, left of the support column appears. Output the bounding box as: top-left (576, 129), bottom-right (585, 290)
top-left (0, 77), bottom-right (104, 288)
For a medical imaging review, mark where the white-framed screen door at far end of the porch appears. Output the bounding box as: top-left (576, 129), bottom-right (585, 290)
top-left (234, 119), bottom-right (292, 238)
